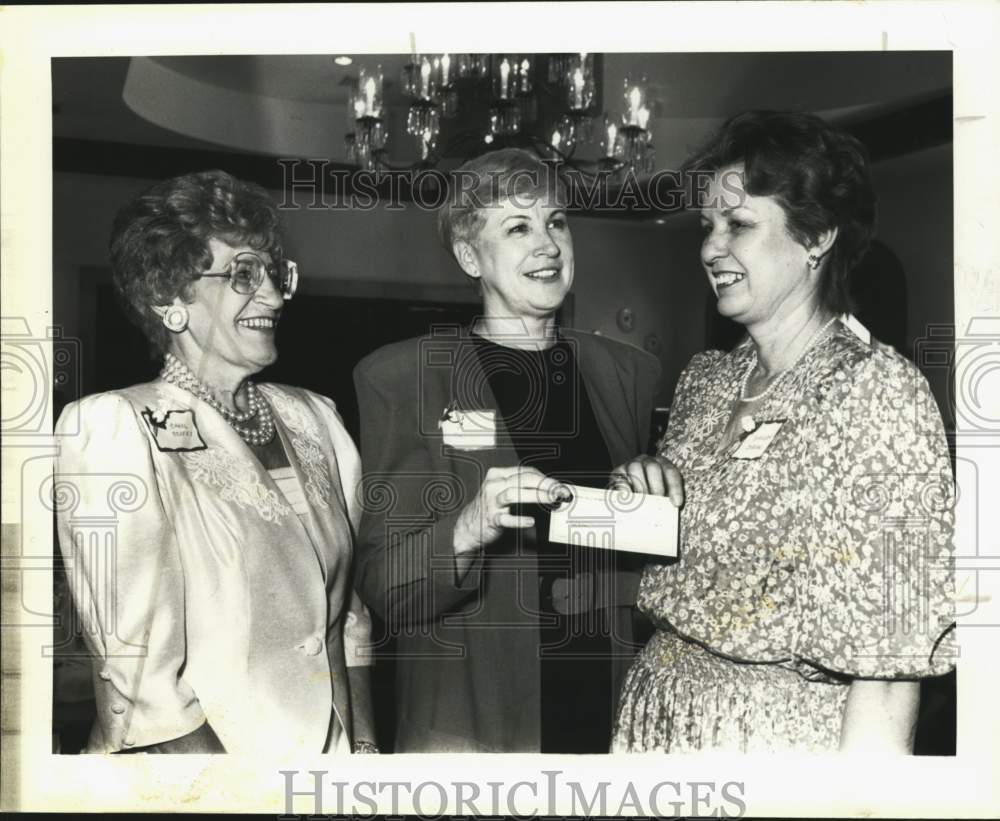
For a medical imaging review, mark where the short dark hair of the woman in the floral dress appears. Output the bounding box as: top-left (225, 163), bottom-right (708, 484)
top-left (684, 111), bottom-right (876, 314)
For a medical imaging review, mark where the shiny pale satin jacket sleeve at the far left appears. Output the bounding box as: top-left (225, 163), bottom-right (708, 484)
top-left (54, 394), bottom-right (205, 752)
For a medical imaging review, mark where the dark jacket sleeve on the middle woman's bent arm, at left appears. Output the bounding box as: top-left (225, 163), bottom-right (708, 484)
top-left (354, 364), bottom-right (483, 629)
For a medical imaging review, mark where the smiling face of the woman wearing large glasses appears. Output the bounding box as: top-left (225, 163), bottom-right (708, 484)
top-left (170, 237), bottom-right (284, 387)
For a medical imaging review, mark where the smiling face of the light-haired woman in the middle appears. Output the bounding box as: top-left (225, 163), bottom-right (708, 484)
top-left (455, 196), bottom-right (573, 318)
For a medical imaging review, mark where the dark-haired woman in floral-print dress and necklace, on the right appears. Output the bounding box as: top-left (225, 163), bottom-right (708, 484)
top-left (612, 112), bottom-right (955, 753)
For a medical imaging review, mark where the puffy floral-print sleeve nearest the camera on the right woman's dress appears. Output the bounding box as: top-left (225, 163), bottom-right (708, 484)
top-left (795, 351), bottom-right (956, 679)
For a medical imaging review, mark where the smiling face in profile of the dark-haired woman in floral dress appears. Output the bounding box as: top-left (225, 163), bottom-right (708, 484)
top-left (701, 166), bottom-right (819, 327)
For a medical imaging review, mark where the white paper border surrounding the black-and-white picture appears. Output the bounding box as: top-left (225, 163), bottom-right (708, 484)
top-left (0, 0), bottom-right (1000, 818)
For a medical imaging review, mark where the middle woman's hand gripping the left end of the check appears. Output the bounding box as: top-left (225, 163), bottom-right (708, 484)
top-left (453, 467), bottom-right (573, 556)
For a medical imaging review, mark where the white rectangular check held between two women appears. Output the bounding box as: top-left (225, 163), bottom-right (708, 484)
top-left (549, 485), bottom-right (680, 556)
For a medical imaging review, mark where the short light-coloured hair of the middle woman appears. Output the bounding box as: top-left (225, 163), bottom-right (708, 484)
top-left (438, 148), bottom-right (567, 253)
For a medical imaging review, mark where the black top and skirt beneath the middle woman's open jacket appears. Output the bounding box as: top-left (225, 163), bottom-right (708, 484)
top-left (472, 334), bottom-right (615, 753)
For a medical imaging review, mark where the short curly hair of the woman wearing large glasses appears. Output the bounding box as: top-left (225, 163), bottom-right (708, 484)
top-left (109, 171), bottom-right (284, 356)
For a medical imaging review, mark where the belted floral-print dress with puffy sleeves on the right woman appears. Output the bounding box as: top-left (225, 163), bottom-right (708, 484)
top-left (612, 323), bottom-right (956, 752)
